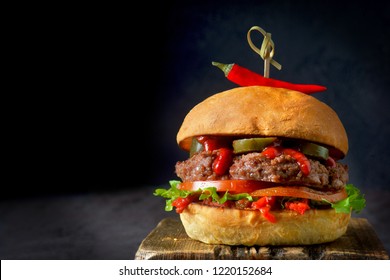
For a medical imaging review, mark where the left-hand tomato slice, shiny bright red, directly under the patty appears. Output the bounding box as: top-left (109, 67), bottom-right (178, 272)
top-left (178, 180), bottom-right (275, 194)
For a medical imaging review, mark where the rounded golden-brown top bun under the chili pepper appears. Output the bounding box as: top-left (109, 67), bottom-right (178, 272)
top-left (177, 86), bottom-right (348, 158)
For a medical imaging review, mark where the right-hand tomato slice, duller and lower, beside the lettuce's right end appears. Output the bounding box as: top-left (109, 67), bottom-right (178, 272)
top-left (250, 187), bottom-right (348, 203)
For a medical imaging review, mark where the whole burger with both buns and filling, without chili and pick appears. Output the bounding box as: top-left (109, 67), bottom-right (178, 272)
top-left (154, 86), bottom-right (365, 246)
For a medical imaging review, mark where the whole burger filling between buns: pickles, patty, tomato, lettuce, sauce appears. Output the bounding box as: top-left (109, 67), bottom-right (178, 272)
top-left (154, 136), bottom-right (365, 222)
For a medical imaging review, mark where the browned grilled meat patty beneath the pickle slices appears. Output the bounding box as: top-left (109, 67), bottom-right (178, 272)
top-left (175, 150), bottom-right (348, 190)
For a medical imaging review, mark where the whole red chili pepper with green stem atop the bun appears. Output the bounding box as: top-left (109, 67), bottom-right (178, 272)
top-left (212, 62), bottom-right (326, 94)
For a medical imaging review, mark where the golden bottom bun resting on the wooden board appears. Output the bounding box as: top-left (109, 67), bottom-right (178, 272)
top-left (180, 203), bottom-right (351, 246)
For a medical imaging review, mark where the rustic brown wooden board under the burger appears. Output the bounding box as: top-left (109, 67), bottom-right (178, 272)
top-left (135, 218), bottom-right (389, 260)
